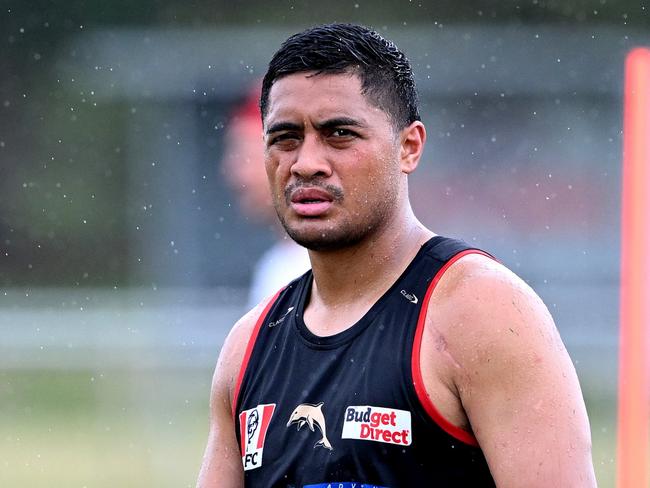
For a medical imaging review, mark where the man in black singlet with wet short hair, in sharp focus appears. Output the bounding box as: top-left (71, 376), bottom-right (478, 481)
top-left (198, 24), bottom-right (595, 488)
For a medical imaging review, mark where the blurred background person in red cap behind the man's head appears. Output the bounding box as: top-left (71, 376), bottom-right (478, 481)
top-left (222, 83), bottom-right (310, 309)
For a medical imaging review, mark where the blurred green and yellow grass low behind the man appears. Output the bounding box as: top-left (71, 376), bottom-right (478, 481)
top-left (0, 369), bottom-right (615, 488)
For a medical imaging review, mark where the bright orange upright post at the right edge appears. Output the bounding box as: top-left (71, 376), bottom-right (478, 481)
top-left (616, 48), bottom-right (650, 488)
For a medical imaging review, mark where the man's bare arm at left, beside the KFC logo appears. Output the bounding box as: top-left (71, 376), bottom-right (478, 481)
top-left (196, 306), bottom-right (262, 488)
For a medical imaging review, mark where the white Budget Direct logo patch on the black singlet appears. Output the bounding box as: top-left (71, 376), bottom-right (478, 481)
top-left (341, 405), bottom-right (411, 446)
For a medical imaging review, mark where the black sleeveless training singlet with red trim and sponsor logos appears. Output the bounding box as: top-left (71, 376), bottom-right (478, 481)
top-left (233, 236), bottom-right (495, 488)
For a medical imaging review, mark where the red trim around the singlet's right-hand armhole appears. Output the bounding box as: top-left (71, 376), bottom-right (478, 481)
top-left (411, 249), bottom-right (494, 446)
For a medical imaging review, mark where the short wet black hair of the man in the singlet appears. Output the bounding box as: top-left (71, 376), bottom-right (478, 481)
top-left (260, 24), bottom-right (420, 130)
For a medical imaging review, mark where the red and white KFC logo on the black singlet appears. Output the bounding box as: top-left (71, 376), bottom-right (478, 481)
top-left (239, 403), bottom-right (275, 471)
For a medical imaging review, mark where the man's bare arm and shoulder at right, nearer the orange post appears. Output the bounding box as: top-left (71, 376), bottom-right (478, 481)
top-left (432, 255), bottom-right (596, 488)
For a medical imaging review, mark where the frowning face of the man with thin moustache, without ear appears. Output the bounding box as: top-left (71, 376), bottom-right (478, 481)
top-left (264, 73), bottom-right (405, 250)
